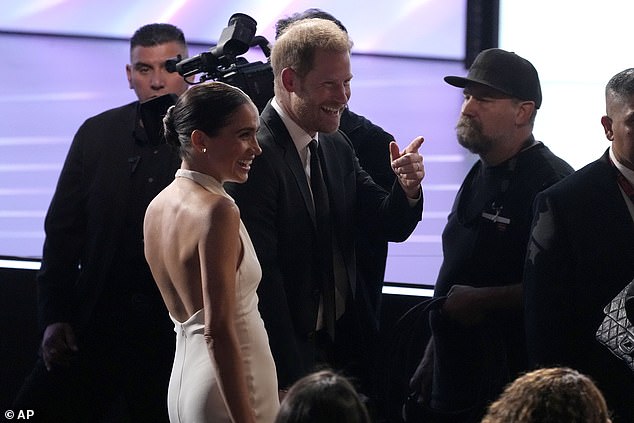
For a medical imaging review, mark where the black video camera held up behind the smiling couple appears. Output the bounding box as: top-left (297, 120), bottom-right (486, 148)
top-left (166, 13), bottom-right (274, 111)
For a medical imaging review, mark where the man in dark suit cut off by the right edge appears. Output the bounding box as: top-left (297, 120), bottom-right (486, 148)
top-left (524, 68), bottom-right (634, 423)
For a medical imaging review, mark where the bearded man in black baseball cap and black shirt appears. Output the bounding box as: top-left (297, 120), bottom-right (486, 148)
top-left (408, 48), bottom-right (573, 423)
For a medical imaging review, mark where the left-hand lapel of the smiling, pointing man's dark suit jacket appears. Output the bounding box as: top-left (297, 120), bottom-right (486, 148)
top-left (261, 103), bottom-right (317, 228)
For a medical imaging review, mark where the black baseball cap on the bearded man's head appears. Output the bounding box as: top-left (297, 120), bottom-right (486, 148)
top-left (445, 48), bottom-right (542, 109)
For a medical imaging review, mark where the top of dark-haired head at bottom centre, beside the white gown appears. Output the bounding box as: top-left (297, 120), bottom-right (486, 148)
top-left (275, 370), bottom-right (370, 423)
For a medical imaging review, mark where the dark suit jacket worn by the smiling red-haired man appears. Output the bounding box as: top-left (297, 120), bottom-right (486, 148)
top-left (227, 104), bottom-right (422, 387)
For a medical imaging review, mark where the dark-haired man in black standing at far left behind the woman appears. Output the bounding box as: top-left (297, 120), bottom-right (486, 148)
top-left (15, 24), bottom-right (187, 422)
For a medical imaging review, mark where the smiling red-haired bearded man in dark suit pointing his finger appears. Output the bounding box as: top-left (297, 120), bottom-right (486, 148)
top-left (228, 19), bottom-right (424, 398)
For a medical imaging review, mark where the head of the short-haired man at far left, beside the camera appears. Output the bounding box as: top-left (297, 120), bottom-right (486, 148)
top-left (126, 23), bottom-right (189, 102)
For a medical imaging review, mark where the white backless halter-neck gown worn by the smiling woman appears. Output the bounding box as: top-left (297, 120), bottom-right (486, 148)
top-left (168, 169), bottom-right (279, 423)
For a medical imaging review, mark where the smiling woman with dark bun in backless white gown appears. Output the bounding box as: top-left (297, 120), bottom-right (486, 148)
top-left (144, 82), bottom-right (279, 423)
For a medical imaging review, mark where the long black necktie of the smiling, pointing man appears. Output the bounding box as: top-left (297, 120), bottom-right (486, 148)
top-left (308, 140), bottom-right (336, 339)
